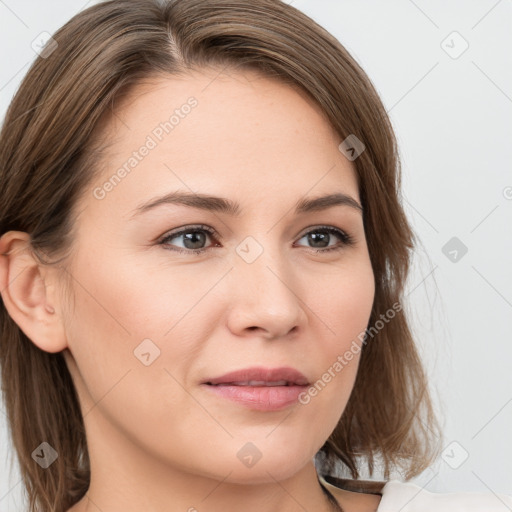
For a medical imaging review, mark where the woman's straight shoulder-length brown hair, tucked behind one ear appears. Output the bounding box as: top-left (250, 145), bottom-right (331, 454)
top-left (0, 0), bottom-right (441, 511)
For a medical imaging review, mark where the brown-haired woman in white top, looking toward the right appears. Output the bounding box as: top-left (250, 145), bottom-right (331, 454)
top-left (0, 0), bottom-right (508, 512)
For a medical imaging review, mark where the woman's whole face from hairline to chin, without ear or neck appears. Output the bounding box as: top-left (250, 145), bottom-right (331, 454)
top-left (61, 70), bottom-right (374, 483)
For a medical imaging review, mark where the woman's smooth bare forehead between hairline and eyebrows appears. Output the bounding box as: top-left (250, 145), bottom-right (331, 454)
top-left (81, 65), bottom-right (358, 214)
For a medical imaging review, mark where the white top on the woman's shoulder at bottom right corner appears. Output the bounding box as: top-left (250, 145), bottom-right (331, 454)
top-left (377, 480), bottom-right (512, 512)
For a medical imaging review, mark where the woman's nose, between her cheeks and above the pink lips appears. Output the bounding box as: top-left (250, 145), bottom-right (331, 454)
top-left (228, 244), bottom-right (307, 339)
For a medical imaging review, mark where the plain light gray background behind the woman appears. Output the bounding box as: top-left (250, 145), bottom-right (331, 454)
top-left (0, 0), bottom-right (512, 511)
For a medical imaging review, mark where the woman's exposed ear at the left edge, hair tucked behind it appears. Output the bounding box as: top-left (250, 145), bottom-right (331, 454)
top-left (0, 231), bottom-right (67, 352)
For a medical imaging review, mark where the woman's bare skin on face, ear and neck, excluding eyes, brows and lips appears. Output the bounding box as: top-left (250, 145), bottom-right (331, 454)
top-left (0, 69), bottom-right (380, 512)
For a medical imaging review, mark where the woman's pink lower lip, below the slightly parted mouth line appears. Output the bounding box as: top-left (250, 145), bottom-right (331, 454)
top-left (204, 384), bottom-right (308, 411)
